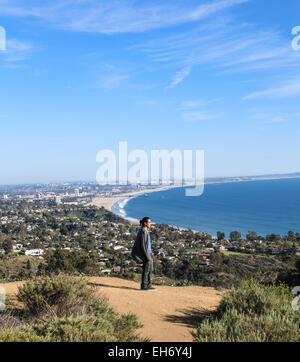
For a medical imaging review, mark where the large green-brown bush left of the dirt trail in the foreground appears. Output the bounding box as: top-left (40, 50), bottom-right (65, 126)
top-left (0, 275), bottom-right (149, 342)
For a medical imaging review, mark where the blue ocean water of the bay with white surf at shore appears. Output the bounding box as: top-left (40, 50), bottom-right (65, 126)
top-left (113, 178), bottom-right (300, 237)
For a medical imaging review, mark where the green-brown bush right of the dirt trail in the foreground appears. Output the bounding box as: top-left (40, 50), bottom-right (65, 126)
top-left (191, 281), bottom-right (300, 342)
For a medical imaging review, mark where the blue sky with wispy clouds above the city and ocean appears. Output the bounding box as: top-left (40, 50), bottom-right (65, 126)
top-left (0, 0), bottom-right (300, 184)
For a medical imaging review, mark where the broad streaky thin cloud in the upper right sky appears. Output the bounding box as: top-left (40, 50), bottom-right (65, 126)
top-left (135, 15), bottom-right (300, 74)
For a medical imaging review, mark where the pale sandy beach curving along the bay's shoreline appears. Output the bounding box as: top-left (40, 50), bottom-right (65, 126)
top-left (91, 186), bottom-right (182, 225)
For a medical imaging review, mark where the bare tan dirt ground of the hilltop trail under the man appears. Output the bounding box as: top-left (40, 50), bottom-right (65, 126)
top-left (0, 277), bottom-right (222, 342)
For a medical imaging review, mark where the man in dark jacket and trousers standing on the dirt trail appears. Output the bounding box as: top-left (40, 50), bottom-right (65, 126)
top-left (131, 217), bottom-right (156, 291)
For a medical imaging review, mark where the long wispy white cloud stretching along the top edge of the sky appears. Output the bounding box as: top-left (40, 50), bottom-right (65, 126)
top-left (0, 0), bottom-right (249, 34)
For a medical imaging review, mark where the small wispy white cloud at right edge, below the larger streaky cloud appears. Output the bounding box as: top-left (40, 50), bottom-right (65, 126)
top-left (243, 80), bottom-right (300, 100)
